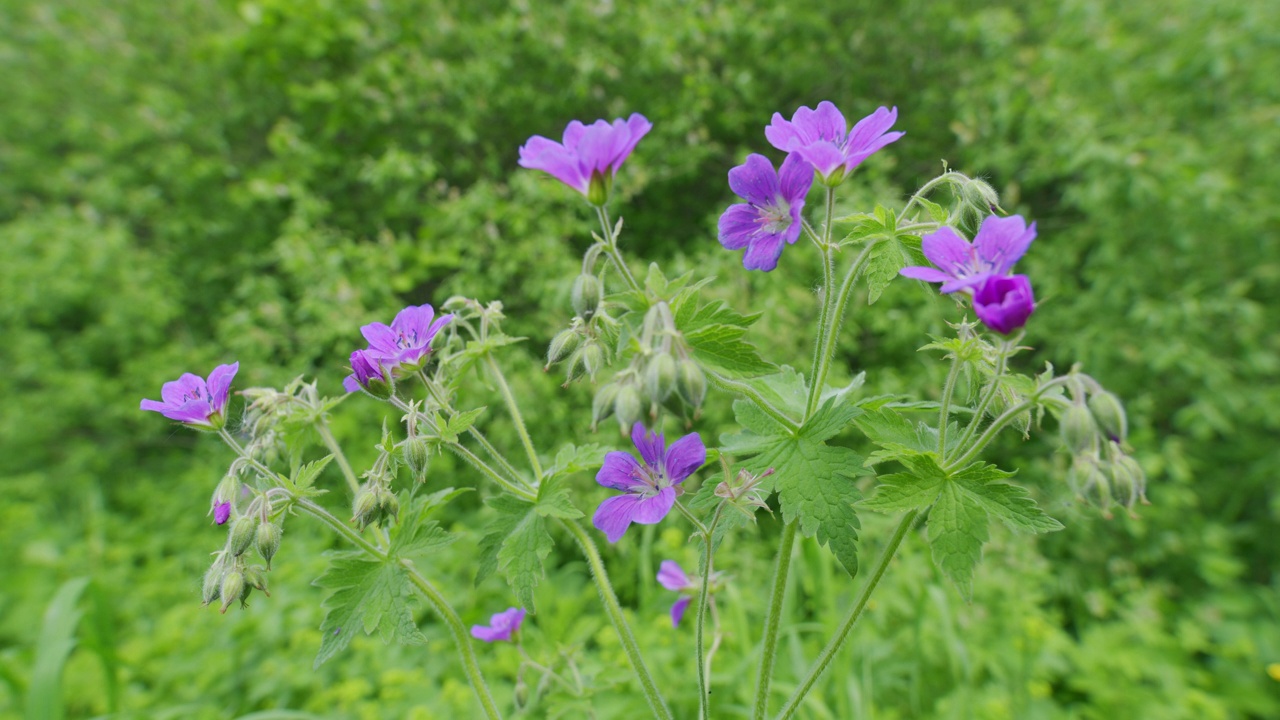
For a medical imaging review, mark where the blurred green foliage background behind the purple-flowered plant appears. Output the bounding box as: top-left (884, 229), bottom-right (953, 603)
top-left (0, 0), bottom-right (1280, 720)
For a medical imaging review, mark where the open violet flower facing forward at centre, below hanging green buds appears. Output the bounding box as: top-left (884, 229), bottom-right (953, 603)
top-left (591, 423), bottom-right (707, 542)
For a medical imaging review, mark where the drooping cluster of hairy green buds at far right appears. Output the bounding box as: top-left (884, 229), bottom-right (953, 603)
top-left (1060, 374), bottom-right (1147, 518)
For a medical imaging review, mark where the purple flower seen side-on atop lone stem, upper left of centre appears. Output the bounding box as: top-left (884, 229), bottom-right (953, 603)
top-left (520, 113), bottom-right (653, 205)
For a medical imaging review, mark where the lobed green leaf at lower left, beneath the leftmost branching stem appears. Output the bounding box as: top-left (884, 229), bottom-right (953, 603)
top-left (312, 552), bottom-right (426, 667)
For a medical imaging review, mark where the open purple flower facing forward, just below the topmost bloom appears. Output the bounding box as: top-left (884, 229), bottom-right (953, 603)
top-left (719, 152), bottom-right (813, 272)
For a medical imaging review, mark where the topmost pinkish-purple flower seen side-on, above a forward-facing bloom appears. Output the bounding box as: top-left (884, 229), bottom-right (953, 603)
top-left (764, 100), bottom-right (906, 187)
